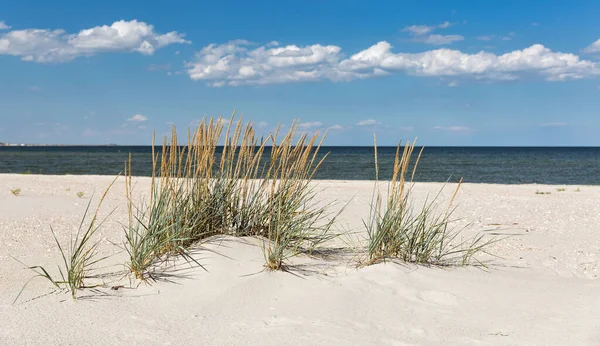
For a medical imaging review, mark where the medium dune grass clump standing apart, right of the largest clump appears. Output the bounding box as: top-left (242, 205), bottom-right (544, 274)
top-left (363, 138), bottom-right (496, 265)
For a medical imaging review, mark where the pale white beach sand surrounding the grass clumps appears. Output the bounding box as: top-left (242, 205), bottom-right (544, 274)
top-left (0, 175), bottom-right (600, 345)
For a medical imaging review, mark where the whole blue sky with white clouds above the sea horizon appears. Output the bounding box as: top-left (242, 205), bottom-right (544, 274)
top-left (0, 0), bottom-right (600, 146)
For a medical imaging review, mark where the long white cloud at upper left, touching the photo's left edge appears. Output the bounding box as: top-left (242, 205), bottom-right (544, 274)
top-left (0, 20), bottom-right (189, 62)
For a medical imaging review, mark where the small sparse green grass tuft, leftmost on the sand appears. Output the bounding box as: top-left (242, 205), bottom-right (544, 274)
top-left (13, 176), bottom-right (118, 303)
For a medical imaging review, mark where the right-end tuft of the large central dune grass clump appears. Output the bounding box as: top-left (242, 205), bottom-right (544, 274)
top-left (263, 125), bottom-right (339, 270)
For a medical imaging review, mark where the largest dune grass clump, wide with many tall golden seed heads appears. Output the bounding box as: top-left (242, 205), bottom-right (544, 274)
top-left (125, 116), bottom-right (333, 279)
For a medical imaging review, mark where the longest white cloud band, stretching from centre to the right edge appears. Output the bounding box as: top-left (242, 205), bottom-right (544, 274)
top-left (187, 40), bottom-right (600, 87)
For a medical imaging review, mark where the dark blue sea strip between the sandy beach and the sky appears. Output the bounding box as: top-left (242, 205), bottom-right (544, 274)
top-left (0, 146), bottom-right (600, 185)
